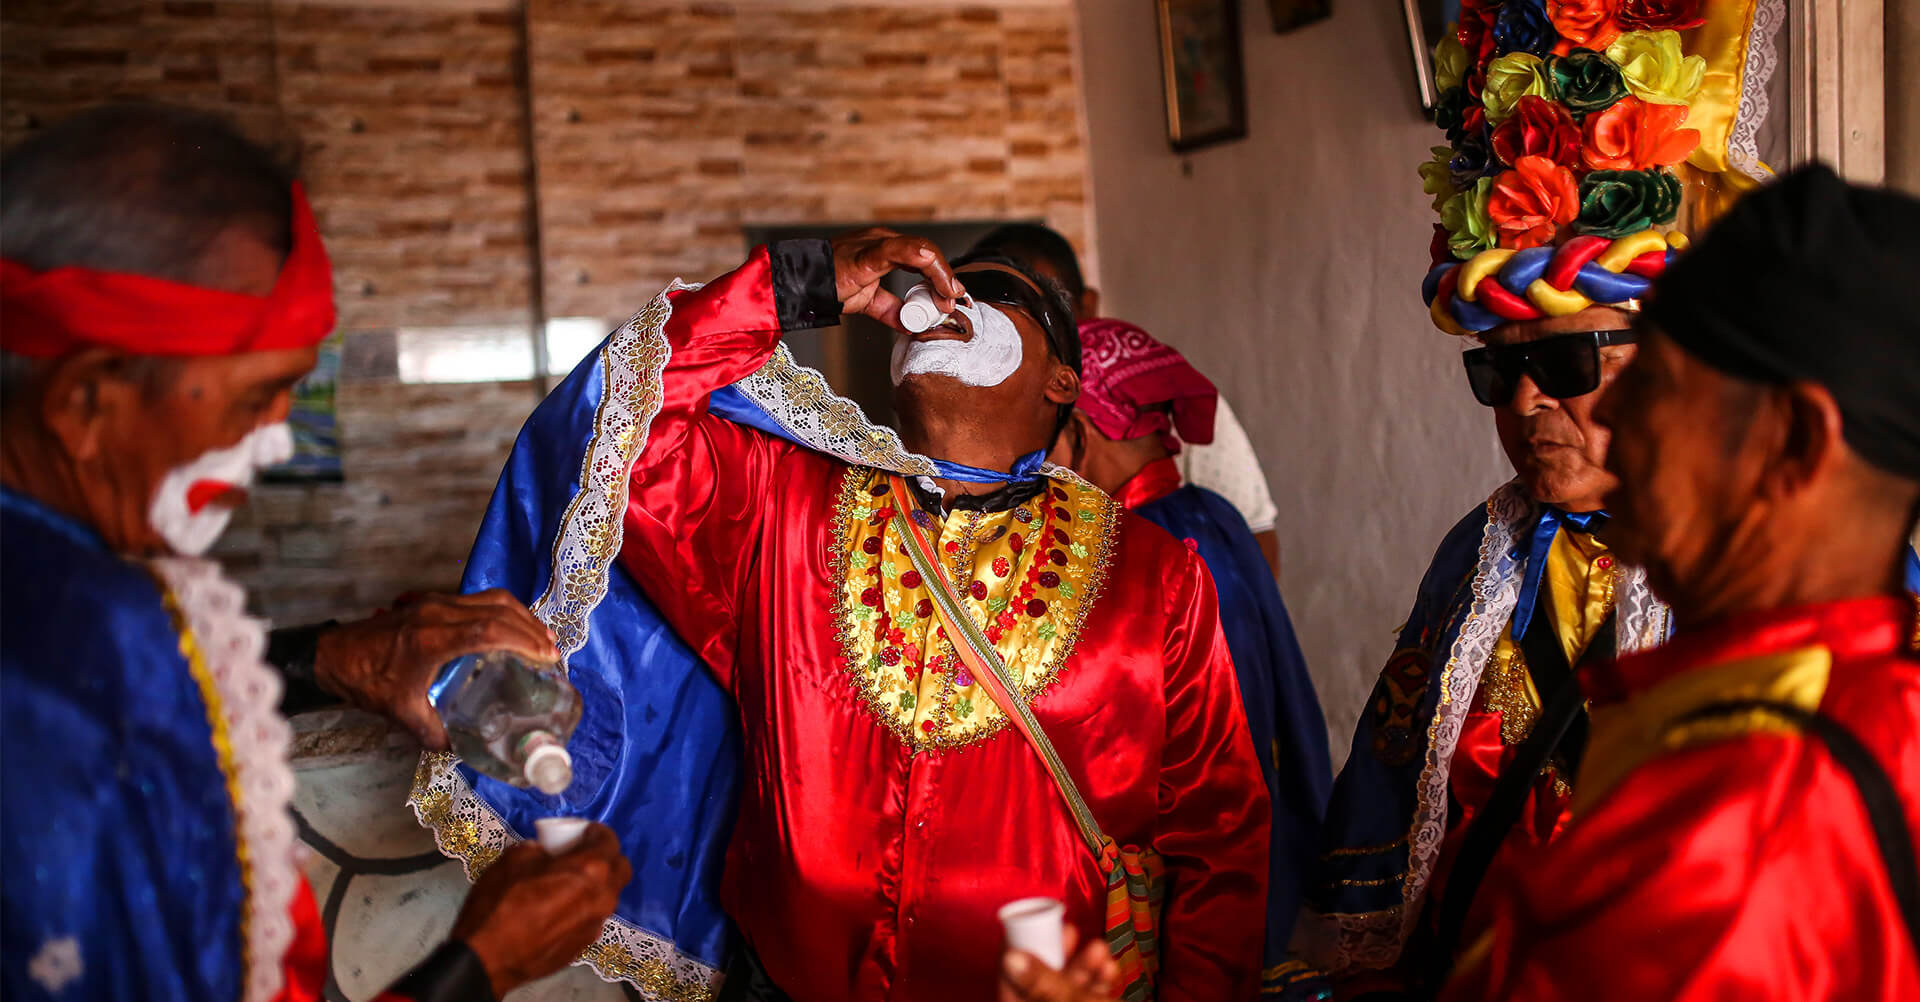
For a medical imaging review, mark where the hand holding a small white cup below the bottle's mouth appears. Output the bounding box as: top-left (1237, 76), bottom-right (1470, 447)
top-left (451, 823), bottom-right (634, 998)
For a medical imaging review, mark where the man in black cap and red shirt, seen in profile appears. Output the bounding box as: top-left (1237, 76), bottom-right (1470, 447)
top-left (1448, 165), bottom-right (1920, 1000)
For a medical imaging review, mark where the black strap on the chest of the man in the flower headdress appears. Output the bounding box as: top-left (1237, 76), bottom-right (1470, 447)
top-left (1415, 595), bottom-right (1615, 989)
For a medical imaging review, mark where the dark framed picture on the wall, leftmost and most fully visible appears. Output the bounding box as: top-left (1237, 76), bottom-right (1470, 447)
top-left (1156, 0), bottom-right (1246, 152)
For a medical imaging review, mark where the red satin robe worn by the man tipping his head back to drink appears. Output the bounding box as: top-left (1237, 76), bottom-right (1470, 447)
top-left (620, 250), bottom-right (1269, 1002)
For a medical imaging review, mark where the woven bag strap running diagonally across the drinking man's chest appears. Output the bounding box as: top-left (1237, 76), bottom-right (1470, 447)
top-left (891, 474), bottom-right (1108, 860)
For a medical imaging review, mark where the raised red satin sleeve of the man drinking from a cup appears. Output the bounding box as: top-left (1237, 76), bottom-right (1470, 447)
top-left (620, 248), bottom-right (791, 685)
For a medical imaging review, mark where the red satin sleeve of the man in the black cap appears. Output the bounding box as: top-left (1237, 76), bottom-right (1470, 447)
top-left (1444, 733), bottom-right (1920, 1002)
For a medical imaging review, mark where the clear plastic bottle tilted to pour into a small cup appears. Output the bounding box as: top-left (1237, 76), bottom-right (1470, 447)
top-left (428, 651), bottom-right (580, 795)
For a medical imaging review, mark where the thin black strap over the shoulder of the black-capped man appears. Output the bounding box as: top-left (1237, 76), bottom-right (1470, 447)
top-left (1676, 699), bottom-right (1920, 958)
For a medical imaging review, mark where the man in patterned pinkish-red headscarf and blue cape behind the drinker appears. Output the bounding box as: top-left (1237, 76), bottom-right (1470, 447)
top-left (1052, 319), bottom-right (1332, 990)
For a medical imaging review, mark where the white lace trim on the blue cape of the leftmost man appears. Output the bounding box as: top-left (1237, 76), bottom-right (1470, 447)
top-left (150, 557), bottom-right (300, 1002)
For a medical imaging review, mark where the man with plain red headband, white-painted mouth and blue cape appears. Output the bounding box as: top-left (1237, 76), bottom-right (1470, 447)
top-left (0, 106), bottom-right (628, 1002)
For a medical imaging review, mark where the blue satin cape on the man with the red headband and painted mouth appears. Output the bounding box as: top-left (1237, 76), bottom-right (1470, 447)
top-left (0, 491), bottom-right (246, 1002)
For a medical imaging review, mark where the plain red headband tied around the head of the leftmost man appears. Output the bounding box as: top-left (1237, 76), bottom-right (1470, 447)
top-left (0, 182), bottom-right (334, 359)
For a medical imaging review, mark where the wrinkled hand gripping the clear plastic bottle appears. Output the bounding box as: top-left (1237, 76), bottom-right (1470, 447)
top-left (313, 589), bottom-right (561, 751)
